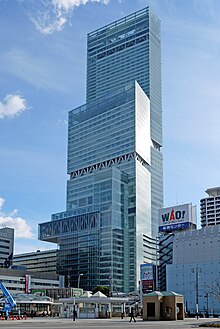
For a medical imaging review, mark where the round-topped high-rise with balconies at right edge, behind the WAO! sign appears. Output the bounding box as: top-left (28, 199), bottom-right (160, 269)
top-left (200, 187), bottom-right (220, 227)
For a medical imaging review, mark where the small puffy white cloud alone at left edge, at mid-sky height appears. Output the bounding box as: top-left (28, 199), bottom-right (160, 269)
top-left (0, 94), bottom-right (27, 119)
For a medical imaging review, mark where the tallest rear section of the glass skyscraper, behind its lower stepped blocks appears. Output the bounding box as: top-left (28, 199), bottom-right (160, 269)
top-left (86, 7), bottom-right (163, 237)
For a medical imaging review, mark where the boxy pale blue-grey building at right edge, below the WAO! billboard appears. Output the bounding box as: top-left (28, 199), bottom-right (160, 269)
top-left (167, 225), bottom-right (220, 315)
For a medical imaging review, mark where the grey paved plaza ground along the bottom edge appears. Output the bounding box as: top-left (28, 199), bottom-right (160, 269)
top-left (0, 318), bottom-right (217, 329)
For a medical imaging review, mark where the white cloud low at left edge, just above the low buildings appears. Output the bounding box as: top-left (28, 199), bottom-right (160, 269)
top-left (0, 196), bottom-right (33, 239)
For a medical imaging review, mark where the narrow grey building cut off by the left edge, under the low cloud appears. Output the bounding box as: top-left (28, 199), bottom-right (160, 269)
top-left (0, 227), bottom-right (14, 268)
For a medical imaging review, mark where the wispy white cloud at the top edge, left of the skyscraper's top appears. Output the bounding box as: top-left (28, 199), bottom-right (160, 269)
top-left (26, 0), bottom-right (110, 35)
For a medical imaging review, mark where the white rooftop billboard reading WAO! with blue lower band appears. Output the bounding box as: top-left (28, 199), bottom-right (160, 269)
top-left (159, 203), bottom-right (196, 232)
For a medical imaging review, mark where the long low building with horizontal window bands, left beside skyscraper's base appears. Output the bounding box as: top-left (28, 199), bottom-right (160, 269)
top-left (13, 249), bottom-right (57, 274)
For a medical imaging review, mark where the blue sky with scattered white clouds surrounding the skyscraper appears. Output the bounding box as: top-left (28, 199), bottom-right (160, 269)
top-left (0, 0), bottom-right (220, 253)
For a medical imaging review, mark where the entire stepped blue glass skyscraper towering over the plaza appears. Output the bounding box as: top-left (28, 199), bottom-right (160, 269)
top-left (39, 7), bottom-right (163, 292)
